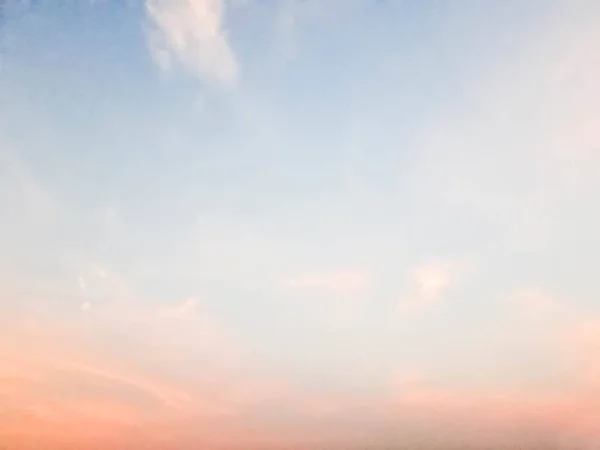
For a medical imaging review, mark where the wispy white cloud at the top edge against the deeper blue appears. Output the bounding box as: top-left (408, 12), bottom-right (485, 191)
top-left (146, 0), bottom-right (239, 85)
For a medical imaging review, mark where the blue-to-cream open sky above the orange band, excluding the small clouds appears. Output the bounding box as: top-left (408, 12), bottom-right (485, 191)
top-left (0, 0), bottom-right (600, 446)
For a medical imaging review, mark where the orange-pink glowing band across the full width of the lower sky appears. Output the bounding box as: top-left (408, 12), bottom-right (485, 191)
top-left (0, 316), bottom-right (600, 450)
